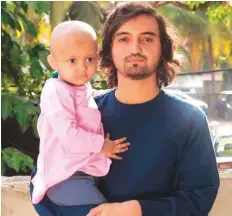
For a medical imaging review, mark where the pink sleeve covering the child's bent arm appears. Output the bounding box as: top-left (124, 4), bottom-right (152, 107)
top-left (38, 81), bottom-right (104, 156)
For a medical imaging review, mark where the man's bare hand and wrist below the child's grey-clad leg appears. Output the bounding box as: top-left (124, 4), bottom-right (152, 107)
top-left (87, 200), bottom-right (142, 216)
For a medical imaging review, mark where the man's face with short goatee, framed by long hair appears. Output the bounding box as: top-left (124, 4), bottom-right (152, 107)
top-left (112, 15), bottom-right (161, 80)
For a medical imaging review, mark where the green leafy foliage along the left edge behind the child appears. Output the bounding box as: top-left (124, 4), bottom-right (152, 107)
top-left (1, 1), bottom-right (49, 174)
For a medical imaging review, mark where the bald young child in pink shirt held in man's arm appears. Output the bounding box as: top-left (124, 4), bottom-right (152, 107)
top-left (32, 21), bottom-right (129, 206)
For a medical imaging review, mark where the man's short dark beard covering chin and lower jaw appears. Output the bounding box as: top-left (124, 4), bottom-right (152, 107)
top-left (119, 64), bottom-right (155, 80)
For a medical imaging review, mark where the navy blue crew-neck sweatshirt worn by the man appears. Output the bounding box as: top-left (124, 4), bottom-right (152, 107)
top-left (96, 90), bottom-right (219, 216)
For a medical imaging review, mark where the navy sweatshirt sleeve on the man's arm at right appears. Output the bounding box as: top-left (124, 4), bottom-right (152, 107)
top-left (139, 112), bottom-right (219, 216)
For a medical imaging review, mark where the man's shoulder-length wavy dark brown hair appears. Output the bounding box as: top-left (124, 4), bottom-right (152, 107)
top-left (100, 2), bottom-right (179, 88)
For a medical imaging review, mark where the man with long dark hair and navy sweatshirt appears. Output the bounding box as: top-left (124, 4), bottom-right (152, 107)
top-left (29, 3), bottom-right (219, 216)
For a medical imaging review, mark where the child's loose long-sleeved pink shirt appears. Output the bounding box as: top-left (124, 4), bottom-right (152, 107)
top-left (32, 78), bottom-right (111, 204)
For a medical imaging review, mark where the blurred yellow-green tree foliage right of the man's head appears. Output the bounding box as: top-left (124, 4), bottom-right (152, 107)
top-left (156, 1), bottom-right (232, 71)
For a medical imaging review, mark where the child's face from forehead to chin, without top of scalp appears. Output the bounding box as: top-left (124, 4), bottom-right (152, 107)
top-left (53, 34), bottom-right (98, 86)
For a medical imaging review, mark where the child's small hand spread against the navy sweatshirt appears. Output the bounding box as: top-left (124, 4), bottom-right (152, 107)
top-left (101, 134), bottom-right (130, 160)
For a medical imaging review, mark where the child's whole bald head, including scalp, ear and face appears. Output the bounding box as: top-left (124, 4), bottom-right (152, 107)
top-left (48, 21), bottom-right (97, 85)
